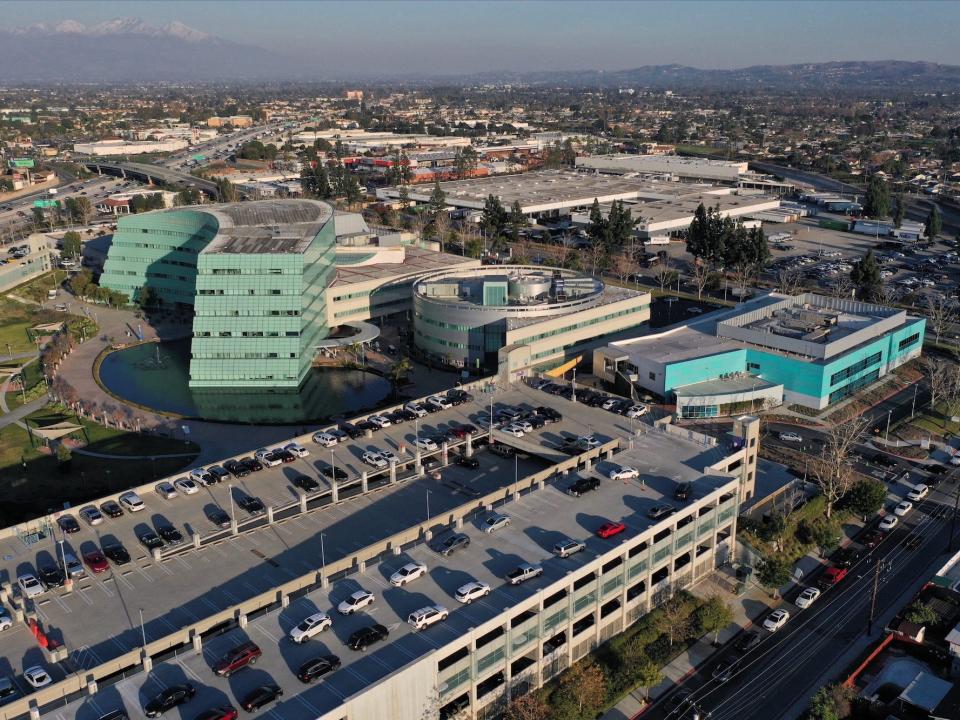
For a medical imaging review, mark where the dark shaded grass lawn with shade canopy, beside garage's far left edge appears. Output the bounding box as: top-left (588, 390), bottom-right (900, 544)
top-left (0, 409), bottom-right (199, 525)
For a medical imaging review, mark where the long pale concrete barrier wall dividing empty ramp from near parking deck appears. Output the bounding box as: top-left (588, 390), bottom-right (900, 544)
top-left (0, 440), bottom-right (620, 720)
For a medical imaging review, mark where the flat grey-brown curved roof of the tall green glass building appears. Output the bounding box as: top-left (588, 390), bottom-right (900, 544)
top-left (195, 200), bottom-right (333, 254)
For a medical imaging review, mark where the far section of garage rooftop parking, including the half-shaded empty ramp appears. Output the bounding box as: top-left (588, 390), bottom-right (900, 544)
top-left (0, 387), bottom-right (652, 708)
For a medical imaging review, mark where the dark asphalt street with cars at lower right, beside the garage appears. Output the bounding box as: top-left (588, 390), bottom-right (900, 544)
top-left (660, 502), bottom-right (949, 720)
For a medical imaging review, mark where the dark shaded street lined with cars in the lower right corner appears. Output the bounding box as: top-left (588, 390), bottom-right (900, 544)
top-left (649, 481), bottom-right (956, 720)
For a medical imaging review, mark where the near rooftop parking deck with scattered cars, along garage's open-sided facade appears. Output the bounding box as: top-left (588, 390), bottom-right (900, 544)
top-left (37, 420), bottom-right (729, 720)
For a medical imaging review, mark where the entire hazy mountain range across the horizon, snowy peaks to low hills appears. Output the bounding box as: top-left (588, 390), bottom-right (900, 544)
top-left (0, 17), bottom-right (960, 93)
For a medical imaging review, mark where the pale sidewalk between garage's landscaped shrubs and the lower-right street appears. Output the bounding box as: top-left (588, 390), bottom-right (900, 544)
top-left (601, 568), bottom-right (782, 720)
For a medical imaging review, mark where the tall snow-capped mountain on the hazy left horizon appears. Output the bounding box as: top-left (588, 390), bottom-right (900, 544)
top-left (0, 18), bottom-right (299, 83)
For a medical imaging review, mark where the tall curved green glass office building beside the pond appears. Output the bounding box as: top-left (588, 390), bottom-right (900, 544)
top-left (100, 200), bottom-right (336, 388)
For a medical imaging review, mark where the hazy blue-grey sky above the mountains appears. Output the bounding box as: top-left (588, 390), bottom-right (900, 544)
top-left (0, 0), bottom-right (960, 74)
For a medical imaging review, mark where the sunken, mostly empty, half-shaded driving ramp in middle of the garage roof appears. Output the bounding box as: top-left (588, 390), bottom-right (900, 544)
top-left (7, 453), bottom-right (543, 668)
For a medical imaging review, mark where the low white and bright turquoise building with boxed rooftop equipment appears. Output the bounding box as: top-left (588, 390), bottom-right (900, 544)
top-left (593, 293), bottom-right (926, 417)
